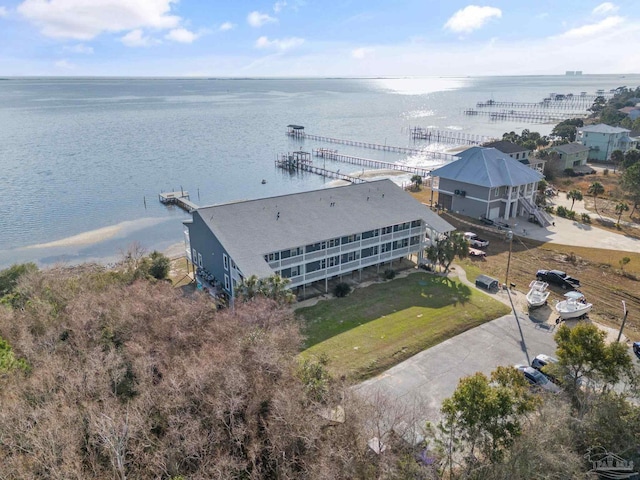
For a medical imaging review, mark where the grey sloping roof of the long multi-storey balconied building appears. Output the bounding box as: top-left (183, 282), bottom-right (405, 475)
top-left (192, 180), bottom-right (455, 277)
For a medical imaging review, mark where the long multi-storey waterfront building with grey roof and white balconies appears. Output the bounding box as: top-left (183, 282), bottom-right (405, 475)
top-left (185, 180), bottom-right (455, 300)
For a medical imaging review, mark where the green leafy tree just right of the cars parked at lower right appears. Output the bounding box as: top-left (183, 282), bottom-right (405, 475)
top-left (554, 323), bottom-right (633, 413)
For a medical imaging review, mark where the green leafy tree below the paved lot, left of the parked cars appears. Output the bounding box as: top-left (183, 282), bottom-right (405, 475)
top-left (439, 367), bottom-right (539, 476)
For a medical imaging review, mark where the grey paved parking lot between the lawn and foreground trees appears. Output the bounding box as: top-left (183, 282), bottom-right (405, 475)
top-left (356, 313), bottom-right (555, 438)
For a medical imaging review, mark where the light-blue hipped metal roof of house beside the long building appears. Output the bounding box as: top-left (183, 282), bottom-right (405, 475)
top-left (431, 147), bottom-right (544, 187)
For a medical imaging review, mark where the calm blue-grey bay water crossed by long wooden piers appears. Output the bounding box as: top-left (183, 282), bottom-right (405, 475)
top-left (0, 75), bottom-right (640, 268)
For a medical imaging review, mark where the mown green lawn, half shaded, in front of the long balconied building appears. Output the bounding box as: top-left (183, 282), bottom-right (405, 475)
top-left (296, 272), bottom-right (509, 380)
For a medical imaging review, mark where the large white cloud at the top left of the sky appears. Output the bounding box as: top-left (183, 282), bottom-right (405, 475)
top-left (17, 0), bottom-right (181, 40)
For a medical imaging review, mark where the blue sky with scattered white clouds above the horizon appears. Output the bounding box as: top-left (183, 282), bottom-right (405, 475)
top-left (0, 0), bottom-right (640, 77)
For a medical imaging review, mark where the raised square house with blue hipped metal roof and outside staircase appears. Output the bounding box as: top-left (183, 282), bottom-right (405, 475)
top-left (431, 147), bottom-right (551, 226)
